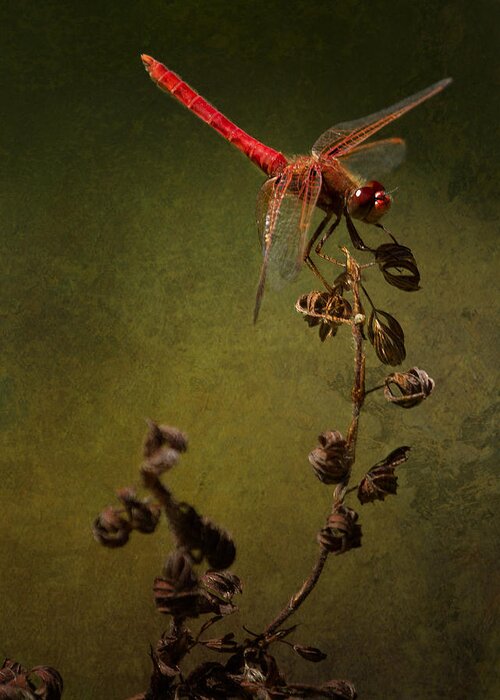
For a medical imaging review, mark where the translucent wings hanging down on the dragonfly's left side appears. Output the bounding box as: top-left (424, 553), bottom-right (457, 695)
top-left (254, 161), bottom-right (322, 320)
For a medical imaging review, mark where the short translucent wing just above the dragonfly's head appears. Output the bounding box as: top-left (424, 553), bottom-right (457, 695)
top-left (339, 138), bottom-right (406, 180)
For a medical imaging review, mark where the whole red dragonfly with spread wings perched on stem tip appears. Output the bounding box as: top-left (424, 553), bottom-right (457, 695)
top-left (141, 54), bottom-right (451, 322)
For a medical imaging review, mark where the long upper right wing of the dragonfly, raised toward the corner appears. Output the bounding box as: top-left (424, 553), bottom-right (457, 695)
top-left (312, 78), bottom-right (451, 158)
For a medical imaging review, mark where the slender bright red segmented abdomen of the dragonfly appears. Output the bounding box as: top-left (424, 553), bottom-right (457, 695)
top-left (141, 54), bottom-right (287, 176)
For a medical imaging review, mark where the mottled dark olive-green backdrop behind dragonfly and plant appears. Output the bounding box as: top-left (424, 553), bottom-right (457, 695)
top-left (0, 0), bottom-right (500, 700)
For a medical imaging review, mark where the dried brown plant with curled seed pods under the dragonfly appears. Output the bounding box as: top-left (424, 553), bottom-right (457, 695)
top-left (86, 216), bottom-right (434, 700)
